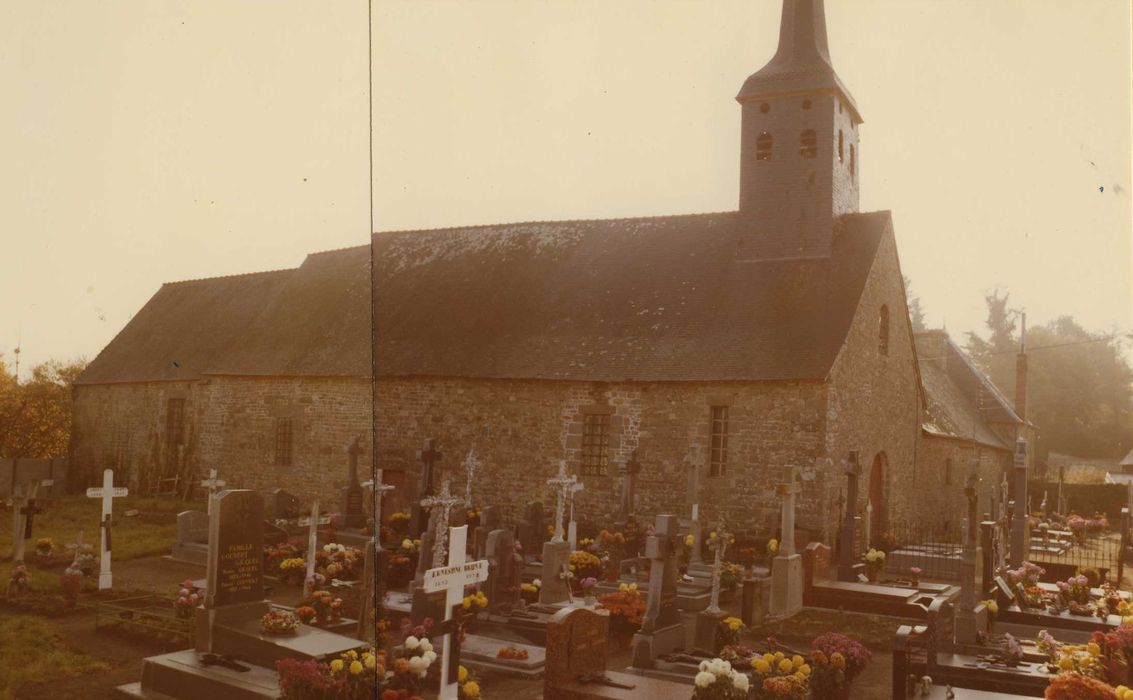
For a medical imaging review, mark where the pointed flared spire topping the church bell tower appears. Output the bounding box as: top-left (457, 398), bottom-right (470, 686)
top-left (735, 0), bottom-right (861, 120)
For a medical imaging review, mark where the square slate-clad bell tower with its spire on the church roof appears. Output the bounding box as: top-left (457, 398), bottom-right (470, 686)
top-left (735, 0), bottom-right (862, 259)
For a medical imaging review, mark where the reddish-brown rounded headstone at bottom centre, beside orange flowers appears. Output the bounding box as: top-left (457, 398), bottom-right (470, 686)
top-left (543, 607), bottom-right (611, 700)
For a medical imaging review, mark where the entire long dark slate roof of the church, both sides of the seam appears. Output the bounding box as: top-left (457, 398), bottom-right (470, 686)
top-left (78, 212), bottom-right (892, 384)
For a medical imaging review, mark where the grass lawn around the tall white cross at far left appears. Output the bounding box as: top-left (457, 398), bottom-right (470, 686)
top-left (0, 495), bottom-right (205, 562)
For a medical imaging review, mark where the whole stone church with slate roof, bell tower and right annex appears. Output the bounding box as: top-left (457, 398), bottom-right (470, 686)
top-left (71, 0), bottom-right (1022, 543)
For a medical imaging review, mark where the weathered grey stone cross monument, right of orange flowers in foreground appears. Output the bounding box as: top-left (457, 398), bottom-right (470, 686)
top-left (633, 515), bottom-right (684, 668)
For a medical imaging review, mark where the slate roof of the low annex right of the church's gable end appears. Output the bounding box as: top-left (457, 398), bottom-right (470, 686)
top-left (917, 331), bottom-right (1021, 450)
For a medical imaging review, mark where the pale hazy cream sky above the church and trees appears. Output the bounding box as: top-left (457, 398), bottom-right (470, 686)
top-left (0, 0), bottom-right (1133, 377)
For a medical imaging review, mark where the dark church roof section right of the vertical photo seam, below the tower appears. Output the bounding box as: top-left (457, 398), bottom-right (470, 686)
top-left (373, 212), bottom-right (892, 382)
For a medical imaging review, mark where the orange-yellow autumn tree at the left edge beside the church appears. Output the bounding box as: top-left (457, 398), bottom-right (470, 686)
top-left (0, 357), bottom-right (86, 458)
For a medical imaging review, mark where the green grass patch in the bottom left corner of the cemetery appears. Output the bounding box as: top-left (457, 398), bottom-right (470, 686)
top-left (0, 614), bottom-right (110, 700)
